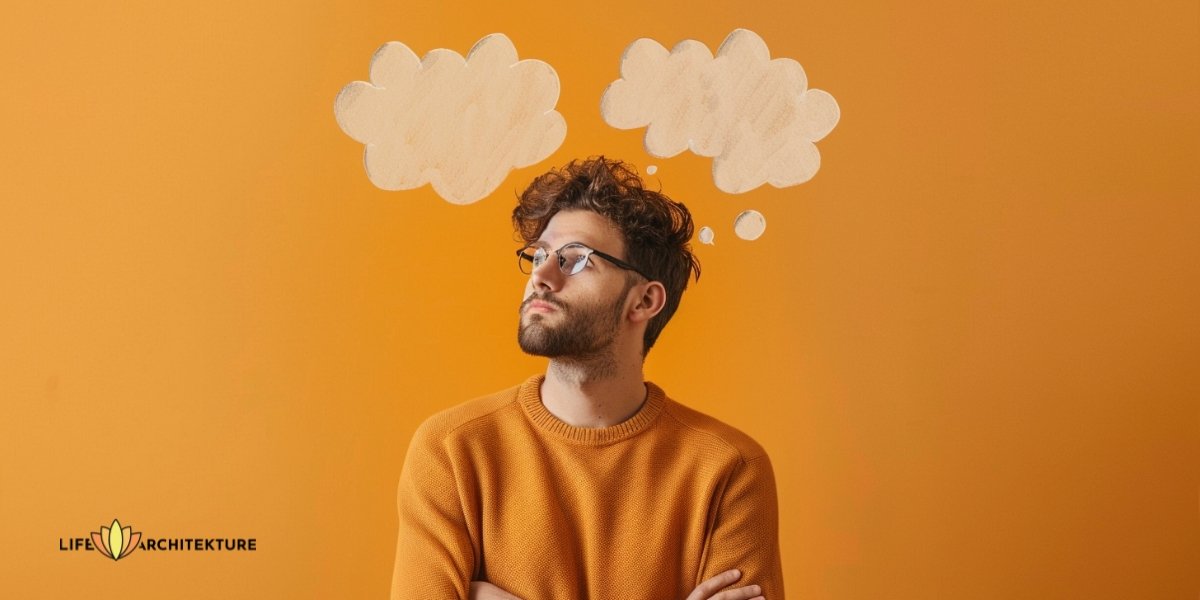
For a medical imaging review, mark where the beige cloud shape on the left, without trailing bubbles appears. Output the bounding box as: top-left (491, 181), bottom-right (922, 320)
top-left (334, 34), bottom-right (566, 204)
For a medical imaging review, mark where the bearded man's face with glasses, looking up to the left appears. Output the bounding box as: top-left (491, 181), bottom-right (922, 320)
top-left (517, 210), bottom-right (629, 359)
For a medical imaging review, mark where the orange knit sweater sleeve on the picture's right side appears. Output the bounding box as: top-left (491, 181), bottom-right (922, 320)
top-left (696, 454), bottom-right (784, 600)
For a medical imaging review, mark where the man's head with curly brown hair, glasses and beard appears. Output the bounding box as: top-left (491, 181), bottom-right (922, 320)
top-left (512, 157), bottom-right (700, 356)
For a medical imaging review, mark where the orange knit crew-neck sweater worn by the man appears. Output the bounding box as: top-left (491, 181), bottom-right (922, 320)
top-left (391, 376), bottom-right (784, 600)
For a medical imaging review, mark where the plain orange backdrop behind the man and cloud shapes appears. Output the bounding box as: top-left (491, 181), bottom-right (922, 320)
top-left (0, 0), bottom-right (1200, 600)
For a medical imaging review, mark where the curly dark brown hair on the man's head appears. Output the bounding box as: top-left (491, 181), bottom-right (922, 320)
top-left (512, 156), bottom-right (700, 356)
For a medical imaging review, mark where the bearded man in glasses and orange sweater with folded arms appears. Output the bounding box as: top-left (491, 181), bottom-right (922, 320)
top-left (391, 157), bottom-right (784, 600)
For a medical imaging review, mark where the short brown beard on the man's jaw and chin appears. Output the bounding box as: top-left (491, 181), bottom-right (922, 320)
top-left (517, 289), bottom-right (625, 360)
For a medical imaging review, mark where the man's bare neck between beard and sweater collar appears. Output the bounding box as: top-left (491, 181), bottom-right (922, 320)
top-left (541, 359), bottom-right (647, 427)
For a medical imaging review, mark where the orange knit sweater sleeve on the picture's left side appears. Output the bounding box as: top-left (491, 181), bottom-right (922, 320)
top-left (391, 421), bottom-right (475, 600)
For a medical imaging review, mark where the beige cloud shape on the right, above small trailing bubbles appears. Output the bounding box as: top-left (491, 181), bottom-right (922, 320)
top-left (600, 29), bottom-right (841, 193)
